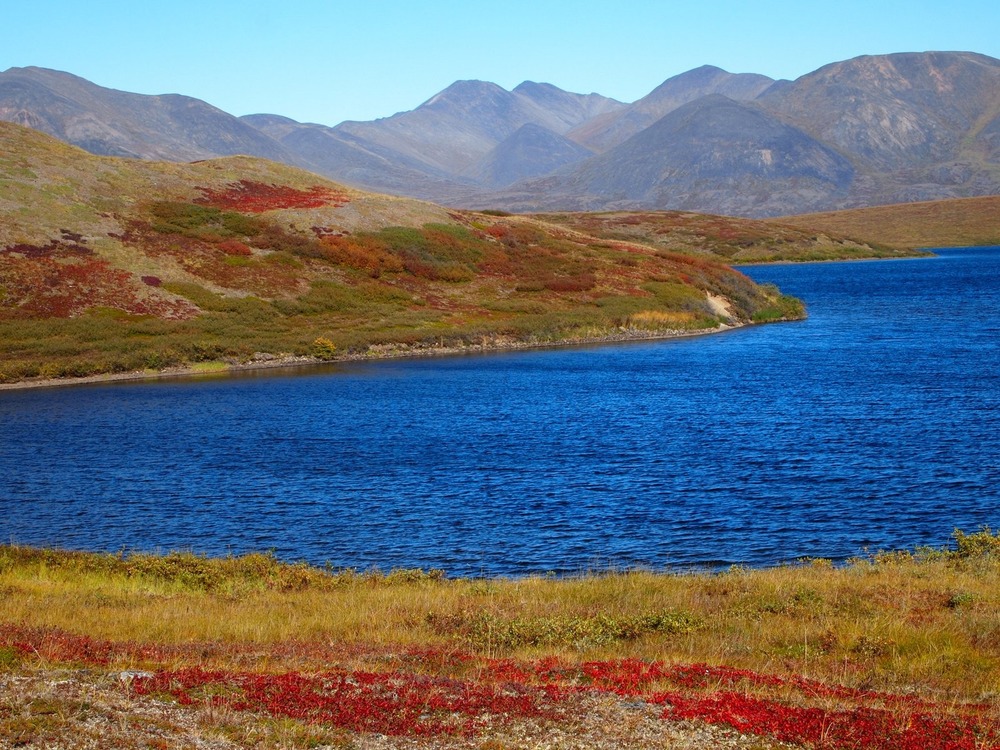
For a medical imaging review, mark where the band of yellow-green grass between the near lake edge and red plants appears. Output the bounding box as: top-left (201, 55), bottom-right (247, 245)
top-left (0, 532), bottom-right (1000, 699)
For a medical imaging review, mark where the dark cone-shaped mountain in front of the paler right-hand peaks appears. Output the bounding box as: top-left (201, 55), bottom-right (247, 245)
top-left (488, 95), bottom-right (854, 214)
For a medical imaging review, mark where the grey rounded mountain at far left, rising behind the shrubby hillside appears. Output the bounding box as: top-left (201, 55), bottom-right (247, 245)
top-left (0, 68), bottom-right (296, 164)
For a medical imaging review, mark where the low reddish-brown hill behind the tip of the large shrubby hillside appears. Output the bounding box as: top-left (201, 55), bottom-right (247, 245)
top-left (537, 211), bottom-right (919, 263)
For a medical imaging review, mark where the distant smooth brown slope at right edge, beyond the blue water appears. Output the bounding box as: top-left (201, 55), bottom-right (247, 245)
top-left (767, 195), bottom-right (1000, 247)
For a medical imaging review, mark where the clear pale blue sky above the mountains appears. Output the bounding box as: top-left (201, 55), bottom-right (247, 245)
top-left (7, 0), bottom-right (1000, 125)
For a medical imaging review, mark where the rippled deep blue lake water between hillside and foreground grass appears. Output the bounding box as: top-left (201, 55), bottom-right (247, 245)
top-left (0, 248), bottom-right (1000, 575)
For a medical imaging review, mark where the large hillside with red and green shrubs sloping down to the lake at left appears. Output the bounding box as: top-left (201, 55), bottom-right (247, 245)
top-left (0, 123), bottom-right (802, 382)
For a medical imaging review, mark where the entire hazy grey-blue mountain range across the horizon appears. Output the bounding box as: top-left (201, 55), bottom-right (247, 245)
top-left (0, 52), bottom-right (1000, 217)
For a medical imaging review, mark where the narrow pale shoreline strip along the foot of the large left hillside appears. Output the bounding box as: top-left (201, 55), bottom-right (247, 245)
top-left (0, 321), bottom-right (752, 391)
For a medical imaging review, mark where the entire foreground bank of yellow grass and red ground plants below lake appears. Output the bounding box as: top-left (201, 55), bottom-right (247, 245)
top-left (0, 529), bottom-right (1000, 750)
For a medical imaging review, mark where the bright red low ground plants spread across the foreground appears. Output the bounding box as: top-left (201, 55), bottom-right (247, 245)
top-left (0, 625), bottom-right (1000, 750)
